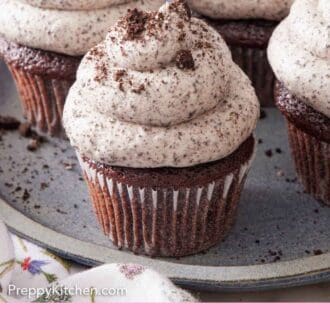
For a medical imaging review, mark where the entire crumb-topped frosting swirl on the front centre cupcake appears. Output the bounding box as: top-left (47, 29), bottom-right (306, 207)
top-left (63, 1), bottom-right (259, 167)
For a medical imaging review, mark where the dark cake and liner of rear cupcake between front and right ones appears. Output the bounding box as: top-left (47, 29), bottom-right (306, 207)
top-left (205, 19), bottom-right (278, 107)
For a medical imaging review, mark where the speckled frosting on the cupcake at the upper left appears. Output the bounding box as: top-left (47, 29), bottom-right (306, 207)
top-left (0, 0), bottom-right (163, 56)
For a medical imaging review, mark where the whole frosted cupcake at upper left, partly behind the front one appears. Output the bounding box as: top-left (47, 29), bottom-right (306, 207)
top-left (0, 0), bottom-right (163, 135)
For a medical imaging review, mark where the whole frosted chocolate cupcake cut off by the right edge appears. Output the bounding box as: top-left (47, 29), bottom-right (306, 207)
top-left (268, 0), bottom-right (330, 205)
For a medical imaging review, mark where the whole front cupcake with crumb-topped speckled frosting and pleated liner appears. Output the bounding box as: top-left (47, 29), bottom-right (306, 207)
top-left (64, 1), bottom-right (259, 256)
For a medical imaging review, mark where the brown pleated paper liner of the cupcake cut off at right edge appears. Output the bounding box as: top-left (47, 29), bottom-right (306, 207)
top-left (287, 120), bottom-right (330, 205)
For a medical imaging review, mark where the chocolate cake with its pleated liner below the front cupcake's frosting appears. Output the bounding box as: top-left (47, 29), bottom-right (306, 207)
top-left (79, 137), bottom-right (255, 257)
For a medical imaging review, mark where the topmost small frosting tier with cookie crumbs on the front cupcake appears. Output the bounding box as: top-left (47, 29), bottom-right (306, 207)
top-left (106, 2), bottom-right (190, 71)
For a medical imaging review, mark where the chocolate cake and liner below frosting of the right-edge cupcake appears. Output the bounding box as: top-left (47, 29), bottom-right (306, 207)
top-left (275, 82), bottom-right (330, 205)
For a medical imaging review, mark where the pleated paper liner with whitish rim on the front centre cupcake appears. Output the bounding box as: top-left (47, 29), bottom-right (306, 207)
top-left (78, 151), bottom-right (252, 257)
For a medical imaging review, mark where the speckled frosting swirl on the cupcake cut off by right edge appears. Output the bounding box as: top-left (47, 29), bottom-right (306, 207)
top-left (268, 0), bottom-right (330, 117)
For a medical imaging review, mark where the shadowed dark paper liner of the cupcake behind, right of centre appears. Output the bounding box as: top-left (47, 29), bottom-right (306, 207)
top-left (229, 45), bottom-right (275, 107)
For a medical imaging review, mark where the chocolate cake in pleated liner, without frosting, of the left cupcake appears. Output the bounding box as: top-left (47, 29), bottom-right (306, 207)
top-left (0, 37), bottom-right (81, 136)
